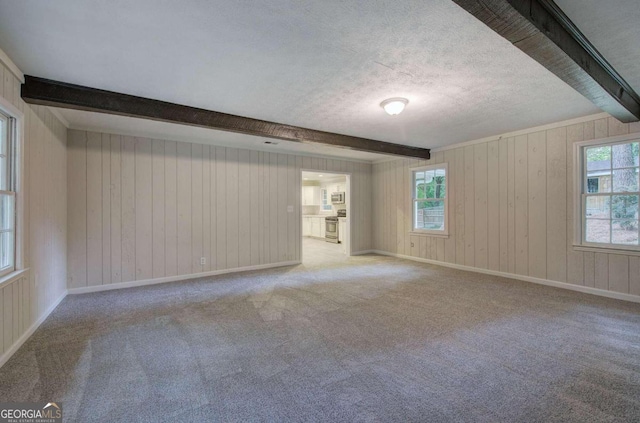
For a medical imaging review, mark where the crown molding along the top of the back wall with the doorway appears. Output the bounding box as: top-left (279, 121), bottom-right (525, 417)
top-left (67, 123), bottom-right (373, 164)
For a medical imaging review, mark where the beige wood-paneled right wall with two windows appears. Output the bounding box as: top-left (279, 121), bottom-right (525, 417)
top-left (373, 118), bottom-right (640, 295)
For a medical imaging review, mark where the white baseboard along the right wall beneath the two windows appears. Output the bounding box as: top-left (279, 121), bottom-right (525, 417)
top-left (372, 250), bottom-right (640, 303)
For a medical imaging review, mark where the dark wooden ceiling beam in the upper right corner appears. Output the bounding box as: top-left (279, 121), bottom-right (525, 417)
top-left (453, 0), bottom-right (640, 122)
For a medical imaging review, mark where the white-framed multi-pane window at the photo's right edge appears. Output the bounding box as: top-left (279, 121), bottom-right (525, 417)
top-left (577, 136), bottom-right (640, 250)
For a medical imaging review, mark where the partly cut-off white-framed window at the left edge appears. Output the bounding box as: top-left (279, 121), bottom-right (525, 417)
top-left (0, 112), bottom-right (16, 276)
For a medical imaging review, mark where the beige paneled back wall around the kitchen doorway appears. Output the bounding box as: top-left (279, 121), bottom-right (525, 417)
top-left (68, 130), bottom-right (372, 288)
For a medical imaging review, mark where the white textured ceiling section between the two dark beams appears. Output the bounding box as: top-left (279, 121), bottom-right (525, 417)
top-left (0, 0), bottom-right (612, 159)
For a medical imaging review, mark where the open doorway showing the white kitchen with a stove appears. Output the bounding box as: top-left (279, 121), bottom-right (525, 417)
top-left (300, 170), bottom-right (351, 265)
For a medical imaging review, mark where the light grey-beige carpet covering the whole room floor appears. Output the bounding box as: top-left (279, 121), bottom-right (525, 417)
top-left (0, 255), bottom-right (640, 422)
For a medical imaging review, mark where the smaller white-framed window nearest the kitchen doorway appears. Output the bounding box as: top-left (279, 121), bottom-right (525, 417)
top-left (411, 163), bottom-right (448, 235)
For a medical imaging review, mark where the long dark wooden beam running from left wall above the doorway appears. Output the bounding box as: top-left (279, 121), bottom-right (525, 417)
top-left (21, 75), bottom-right (430, 159)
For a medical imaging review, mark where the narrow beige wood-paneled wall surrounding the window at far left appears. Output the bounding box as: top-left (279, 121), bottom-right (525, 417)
top-left (0, 63), bottom-right (67, 361)
